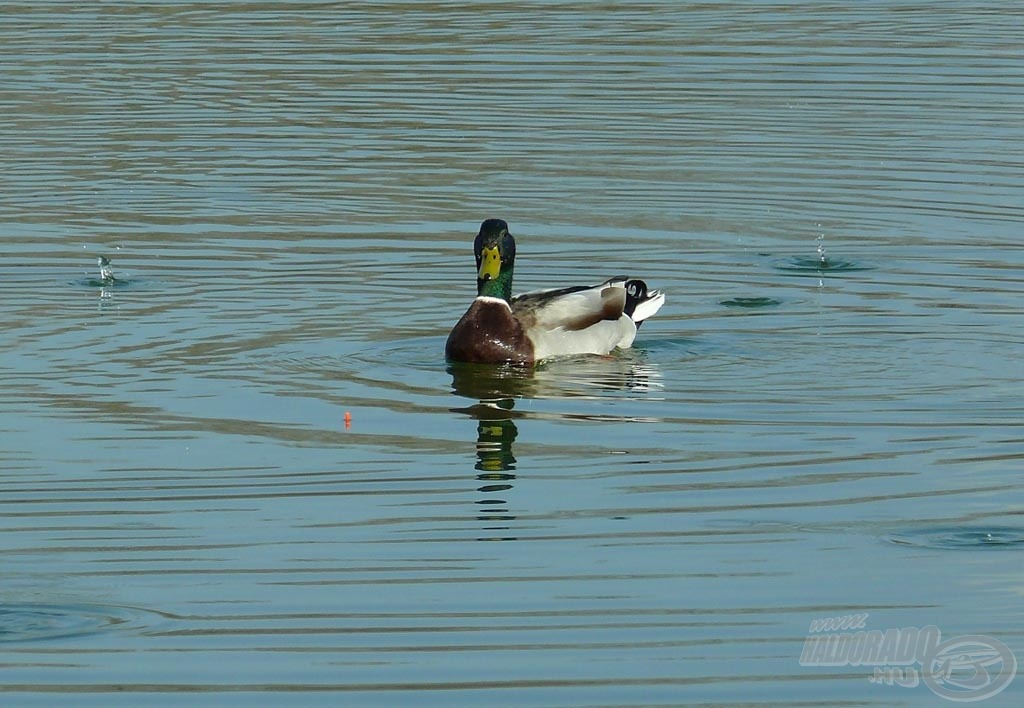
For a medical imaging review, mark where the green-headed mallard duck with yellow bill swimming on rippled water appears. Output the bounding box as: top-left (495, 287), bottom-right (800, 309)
top-left (444, 219), bottom-right (665, 365)
